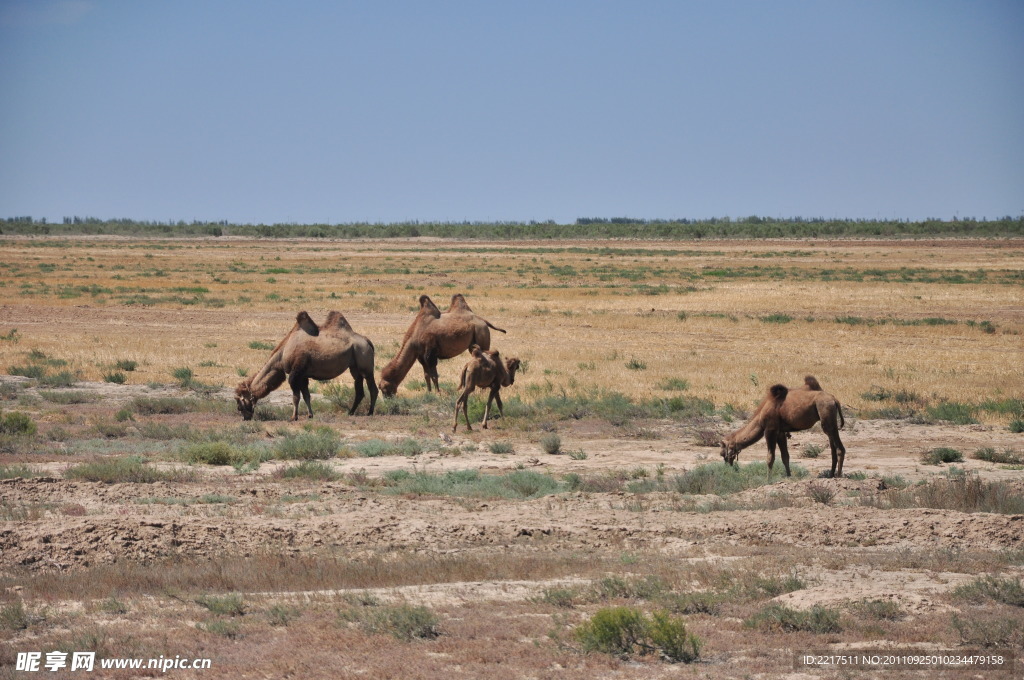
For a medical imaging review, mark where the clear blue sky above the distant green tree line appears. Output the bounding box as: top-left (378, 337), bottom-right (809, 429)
top-left (0, 0), bottom-right (1024, 223)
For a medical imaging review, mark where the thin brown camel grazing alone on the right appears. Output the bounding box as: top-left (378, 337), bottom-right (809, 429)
top-left (722, 376), bottom-right (846, 477)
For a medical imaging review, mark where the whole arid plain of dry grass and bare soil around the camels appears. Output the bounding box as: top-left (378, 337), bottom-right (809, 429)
top-left (0, 238), bottom-right (1024, 678)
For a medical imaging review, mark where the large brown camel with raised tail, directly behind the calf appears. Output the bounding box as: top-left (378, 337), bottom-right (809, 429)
top-left (381, 293), bottom-right (505, 396)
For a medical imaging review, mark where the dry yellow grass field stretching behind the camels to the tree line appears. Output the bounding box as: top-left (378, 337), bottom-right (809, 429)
top-left (0, 239), bottom-right (1024, 420)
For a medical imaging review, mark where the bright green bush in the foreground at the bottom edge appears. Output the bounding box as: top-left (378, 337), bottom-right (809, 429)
top-left (572, 607), bottom-right (701, 664)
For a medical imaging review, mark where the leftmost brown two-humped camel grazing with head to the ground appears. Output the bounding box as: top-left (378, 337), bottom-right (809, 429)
top-left (234, 311), bottom-right (378, 421)
